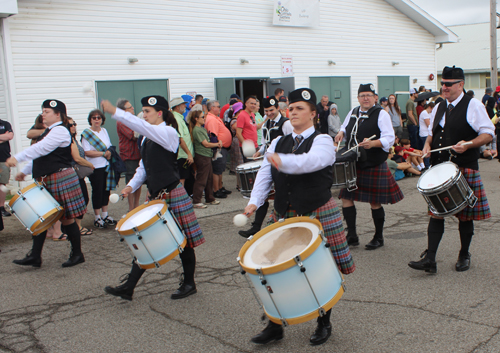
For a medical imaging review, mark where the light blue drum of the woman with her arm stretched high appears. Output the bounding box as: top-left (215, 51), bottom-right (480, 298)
top-left (116, 200), bottom-right (187, 269)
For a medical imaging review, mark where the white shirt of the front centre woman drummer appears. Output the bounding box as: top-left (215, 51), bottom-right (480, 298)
top-left (248, 126), bottom-right (337, 207)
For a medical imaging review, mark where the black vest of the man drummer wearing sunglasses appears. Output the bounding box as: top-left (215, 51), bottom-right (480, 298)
top-left (431, 94), bottom-right (479, 170)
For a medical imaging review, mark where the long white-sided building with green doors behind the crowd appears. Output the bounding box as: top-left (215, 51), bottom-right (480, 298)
top-left (0, 0), bottom-right (457, 179)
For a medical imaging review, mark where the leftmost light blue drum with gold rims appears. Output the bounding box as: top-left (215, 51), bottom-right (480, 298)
top-left (9, 181), bottom-right (64, 235)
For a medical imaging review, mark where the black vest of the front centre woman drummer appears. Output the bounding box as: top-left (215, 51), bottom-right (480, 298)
top-left (271, 131), bottom-right (333, 215)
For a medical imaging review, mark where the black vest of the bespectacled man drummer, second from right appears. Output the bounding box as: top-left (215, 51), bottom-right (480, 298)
top-left (346, 105), bottom-right (389, 169)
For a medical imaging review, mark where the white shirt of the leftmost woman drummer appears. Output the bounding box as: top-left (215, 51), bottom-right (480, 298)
top-left (14, 121), bottom-right (71, 175)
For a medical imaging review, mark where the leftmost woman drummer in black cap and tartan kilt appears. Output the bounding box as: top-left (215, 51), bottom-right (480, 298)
top-left (6, 99), bottom-right (86, 267)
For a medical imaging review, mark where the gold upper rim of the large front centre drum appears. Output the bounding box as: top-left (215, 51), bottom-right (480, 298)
top-left (238, 216), bottom-right (323, 275)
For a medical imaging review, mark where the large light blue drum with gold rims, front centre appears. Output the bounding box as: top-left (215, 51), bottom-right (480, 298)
top-left (238, 217), bottom-right (344, 325)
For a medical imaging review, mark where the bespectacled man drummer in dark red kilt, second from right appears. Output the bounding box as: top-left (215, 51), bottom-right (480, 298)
top-left (335, 83), bottom-right (403, 250)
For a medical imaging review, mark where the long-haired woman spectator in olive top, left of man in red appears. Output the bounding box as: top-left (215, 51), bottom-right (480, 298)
top-left (189, 110), bottom-right (222, 208)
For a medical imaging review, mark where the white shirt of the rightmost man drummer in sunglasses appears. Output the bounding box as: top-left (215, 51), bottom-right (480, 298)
top-left (429, 92), bottom-right (495, 138)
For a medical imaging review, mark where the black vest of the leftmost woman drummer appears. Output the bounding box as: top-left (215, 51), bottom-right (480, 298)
top-left (33, 125), bottom-right (73, 178)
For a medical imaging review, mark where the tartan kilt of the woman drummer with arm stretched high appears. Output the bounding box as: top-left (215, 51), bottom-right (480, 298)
top-left (161, 183), bottom-right (205, 248)
